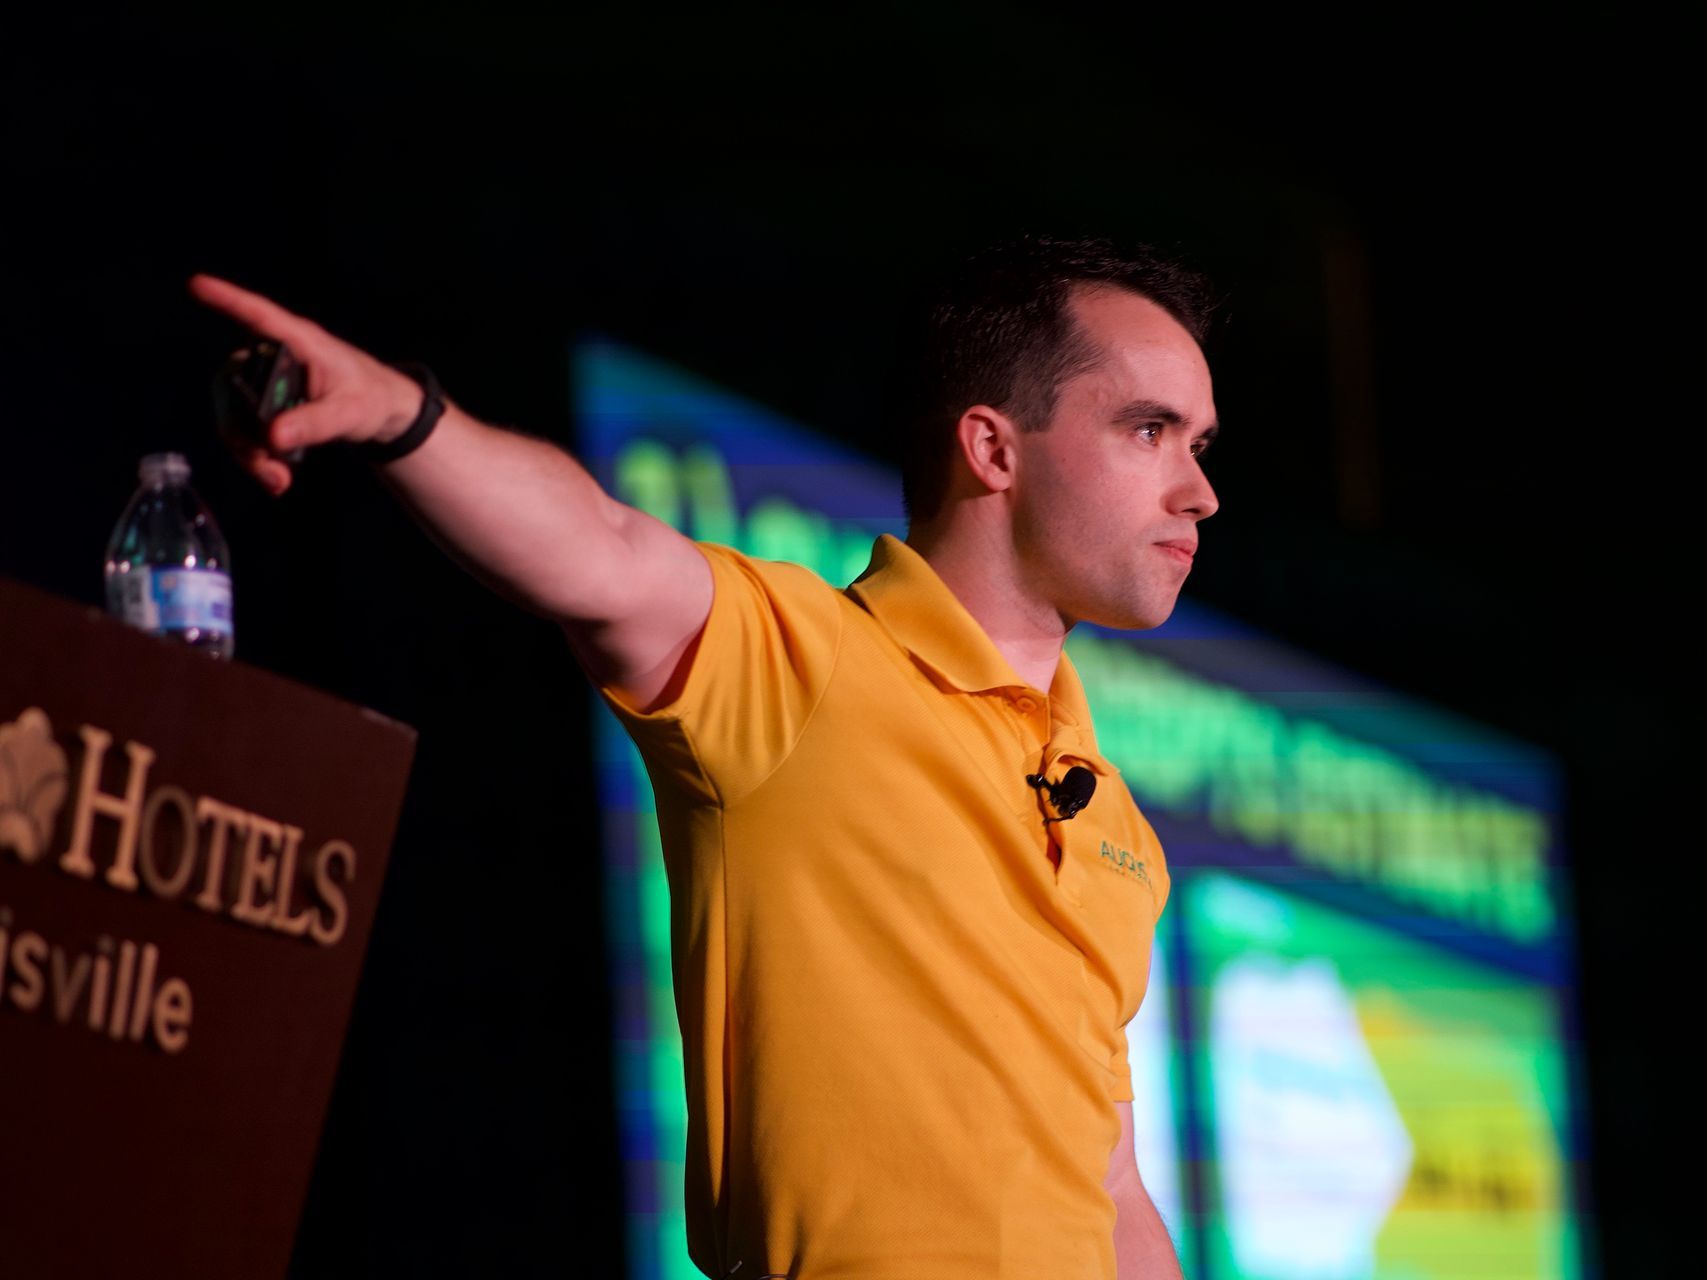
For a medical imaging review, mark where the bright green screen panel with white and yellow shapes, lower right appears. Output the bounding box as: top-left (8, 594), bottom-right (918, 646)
top-left (1181, 872), bottom-right (1577, 1280)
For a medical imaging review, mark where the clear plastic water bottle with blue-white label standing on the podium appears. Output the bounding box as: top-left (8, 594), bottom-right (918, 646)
top-left (106, 454), bottom-right (236, 659)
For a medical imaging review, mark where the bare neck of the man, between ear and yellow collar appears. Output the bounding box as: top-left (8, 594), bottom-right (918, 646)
top-left (906, 521), bottom-right (1072, 693)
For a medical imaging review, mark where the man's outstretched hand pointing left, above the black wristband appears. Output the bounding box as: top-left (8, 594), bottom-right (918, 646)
top-left (189, 275), bottom-right (422, 497)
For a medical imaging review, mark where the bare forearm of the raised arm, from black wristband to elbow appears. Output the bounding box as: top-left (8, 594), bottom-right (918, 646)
top-left (377, 403), bottom-right (630, 618)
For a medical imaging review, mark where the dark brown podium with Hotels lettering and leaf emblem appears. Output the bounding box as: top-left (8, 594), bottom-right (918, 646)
top-left (0, 580), bottom-right (415, 1277)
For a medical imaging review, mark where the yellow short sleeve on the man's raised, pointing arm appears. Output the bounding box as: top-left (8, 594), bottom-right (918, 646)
top-left (597, 543), bottom-right (842, 806)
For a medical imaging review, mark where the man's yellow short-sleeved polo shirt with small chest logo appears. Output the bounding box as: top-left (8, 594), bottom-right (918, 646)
top-left (603, 534), bottom-right (1168, 1280)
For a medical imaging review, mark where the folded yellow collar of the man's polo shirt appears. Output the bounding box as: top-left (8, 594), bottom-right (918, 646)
top-left (848, 534), bottom-right (1094, 751)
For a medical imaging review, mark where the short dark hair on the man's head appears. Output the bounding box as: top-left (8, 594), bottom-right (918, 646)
top-left (901, 236), bottom-right (1215, 521)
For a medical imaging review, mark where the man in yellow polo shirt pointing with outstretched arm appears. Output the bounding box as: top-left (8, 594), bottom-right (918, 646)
top-left (193, 239), bottom-right (1215, 1280)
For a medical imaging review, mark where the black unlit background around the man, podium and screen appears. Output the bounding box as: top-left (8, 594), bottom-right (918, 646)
top-left (0, 12), bottom-right (1698, 1275)
